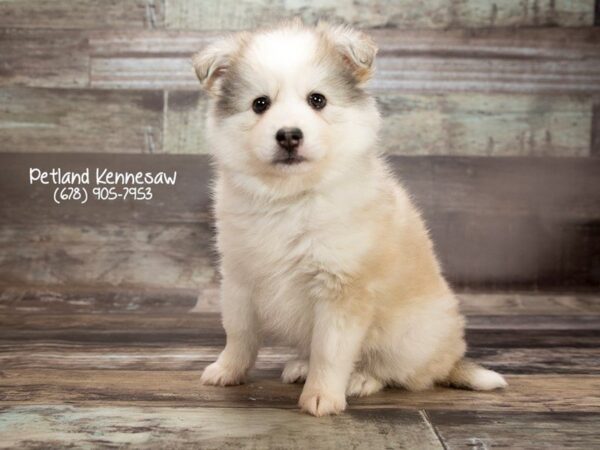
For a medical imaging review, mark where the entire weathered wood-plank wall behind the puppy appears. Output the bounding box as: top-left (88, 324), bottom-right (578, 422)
top-left (0, 0), bottom-right (600, 295)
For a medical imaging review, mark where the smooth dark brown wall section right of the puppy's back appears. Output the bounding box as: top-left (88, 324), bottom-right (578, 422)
top-left (392, 157), bottom-right (600, 287)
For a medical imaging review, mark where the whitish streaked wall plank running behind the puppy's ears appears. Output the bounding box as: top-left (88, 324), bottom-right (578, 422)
top-left (83, 28), bottom-right (600, 93)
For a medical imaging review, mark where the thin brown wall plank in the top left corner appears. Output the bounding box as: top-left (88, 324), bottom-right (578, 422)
top-left (0, 0), bottom-right (164, 29)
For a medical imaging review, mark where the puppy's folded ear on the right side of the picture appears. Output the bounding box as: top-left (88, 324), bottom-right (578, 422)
top-left (317, 22), bottom-right (377, 84)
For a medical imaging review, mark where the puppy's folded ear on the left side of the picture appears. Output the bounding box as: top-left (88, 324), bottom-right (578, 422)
top-left (192, 33), bottom-right (246, 93)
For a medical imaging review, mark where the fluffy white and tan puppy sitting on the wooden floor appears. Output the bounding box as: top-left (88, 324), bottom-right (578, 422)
top-left (193, 22), bottom-right (506, 416)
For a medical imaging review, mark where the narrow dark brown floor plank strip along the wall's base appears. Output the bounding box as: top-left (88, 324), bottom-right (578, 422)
top-left (0, 286), bottom-right (600, 317)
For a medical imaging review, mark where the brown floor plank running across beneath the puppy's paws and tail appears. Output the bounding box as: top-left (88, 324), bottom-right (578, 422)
top-left (0, 369), bottom-right (600, 412)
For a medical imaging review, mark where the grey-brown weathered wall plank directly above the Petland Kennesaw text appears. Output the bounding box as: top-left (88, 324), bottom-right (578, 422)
top-left (0, 87), bottom-right (163, 153)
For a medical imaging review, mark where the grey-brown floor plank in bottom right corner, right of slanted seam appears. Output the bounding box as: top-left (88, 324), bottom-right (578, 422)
top-left (427, 411), bottom-right (600, 449)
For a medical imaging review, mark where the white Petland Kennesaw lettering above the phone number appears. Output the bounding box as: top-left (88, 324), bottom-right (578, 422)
top-left (29, 167), bottom-right (177, 185)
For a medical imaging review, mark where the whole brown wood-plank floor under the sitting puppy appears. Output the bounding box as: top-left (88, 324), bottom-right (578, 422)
top-left (0, 288), bottom-right (600, 449)
